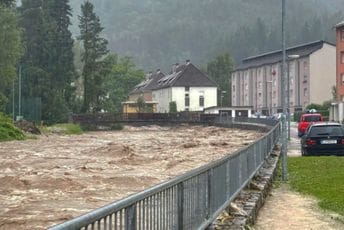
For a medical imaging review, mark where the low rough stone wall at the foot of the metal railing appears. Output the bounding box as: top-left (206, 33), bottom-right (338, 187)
top-left (208, 148), bottom-right (279, 230)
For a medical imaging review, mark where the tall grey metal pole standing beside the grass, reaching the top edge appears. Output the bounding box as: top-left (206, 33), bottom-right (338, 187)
top-left (281, 0), bottom-right (288, 181)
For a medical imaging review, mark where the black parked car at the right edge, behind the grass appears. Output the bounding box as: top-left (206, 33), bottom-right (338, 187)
top-left (301, 122), bottom-right (344, 156)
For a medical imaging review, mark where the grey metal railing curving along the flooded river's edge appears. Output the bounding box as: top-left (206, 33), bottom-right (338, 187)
top-left (51, 118), bottom-right (281, 230)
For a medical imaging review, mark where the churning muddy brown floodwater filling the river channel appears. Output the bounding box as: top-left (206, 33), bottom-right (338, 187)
top-left (0, 125), bottom-right (263, 230)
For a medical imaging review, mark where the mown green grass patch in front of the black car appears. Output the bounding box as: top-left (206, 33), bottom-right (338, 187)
top-left (288, 156), bottom-right (344, 216)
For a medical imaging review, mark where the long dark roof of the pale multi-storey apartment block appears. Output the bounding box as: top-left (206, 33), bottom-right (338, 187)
top-left (235, 40), bottom-right (335, 70)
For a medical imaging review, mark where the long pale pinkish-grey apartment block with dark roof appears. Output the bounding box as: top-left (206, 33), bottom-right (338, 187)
top-left (231, 41), bottom-right (336, 115)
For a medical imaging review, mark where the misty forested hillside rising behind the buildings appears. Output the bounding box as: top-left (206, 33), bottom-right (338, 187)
top-left (71, 0), bottom-right (344, 71)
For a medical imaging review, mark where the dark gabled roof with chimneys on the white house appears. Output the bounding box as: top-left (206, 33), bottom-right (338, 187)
top-left (152, 63), bottom-right (217, 90)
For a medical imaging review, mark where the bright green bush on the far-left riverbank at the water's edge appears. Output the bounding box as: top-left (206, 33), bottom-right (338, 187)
top-left (0, 113), bottom-right (25, 141)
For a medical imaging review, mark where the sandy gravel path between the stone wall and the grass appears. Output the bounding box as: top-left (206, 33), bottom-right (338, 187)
top-left (254, 184), bottom-right (344, 230)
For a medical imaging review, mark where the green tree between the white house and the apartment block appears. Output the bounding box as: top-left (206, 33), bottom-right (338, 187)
top-left (207, 53), bottom-right (233, 106)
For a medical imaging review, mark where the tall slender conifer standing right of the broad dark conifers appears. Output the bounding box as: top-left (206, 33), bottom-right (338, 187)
top-left (78, 1), bottom-right (108, 112)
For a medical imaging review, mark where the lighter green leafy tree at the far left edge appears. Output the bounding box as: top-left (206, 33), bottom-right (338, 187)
top-left (0, 5), bottom-right (23, 112)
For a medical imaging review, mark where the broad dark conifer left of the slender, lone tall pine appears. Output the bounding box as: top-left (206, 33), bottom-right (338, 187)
top-left (20, 0), bottom-right (75, 123)
